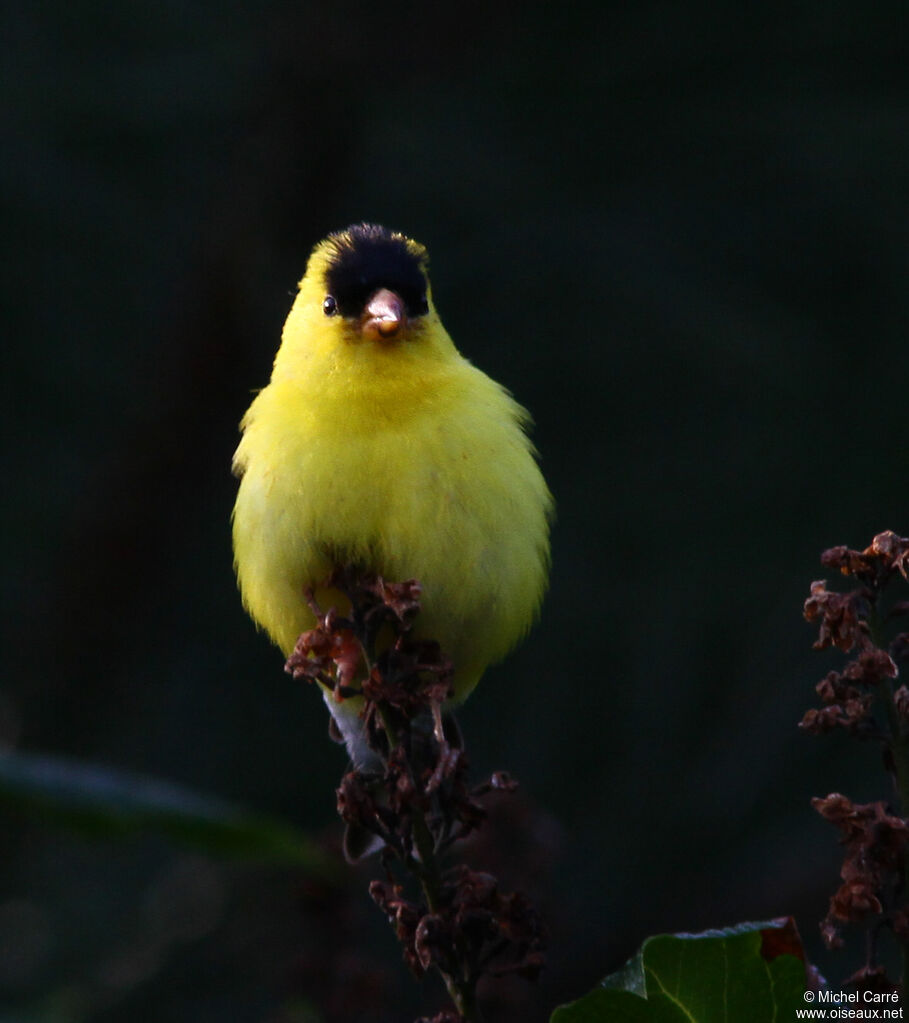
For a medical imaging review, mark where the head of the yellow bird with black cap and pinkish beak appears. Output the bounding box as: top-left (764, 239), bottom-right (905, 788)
top-left (271, 224), bottom-right (453, 378)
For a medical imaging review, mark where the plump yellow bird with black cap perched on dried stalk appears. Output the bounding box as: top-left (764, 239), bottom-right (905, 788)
top-left (233, 224), bottom-right (552, 762)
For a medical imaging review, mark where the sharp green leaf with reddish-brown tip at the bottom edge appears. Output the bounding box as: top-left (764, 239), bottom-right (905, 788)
top-left (550, 918), bottom-right (806, 1023)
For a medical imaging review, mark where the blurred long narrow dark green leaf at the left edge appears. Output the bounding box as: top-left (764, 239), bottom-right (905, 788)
top-left (0, 753), bottom-right (336, 877)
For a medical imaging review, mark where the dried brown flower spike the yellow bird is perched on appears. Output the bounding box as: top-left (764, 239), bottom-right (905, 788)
top-left (286, 568), bottom-right (545, 1023)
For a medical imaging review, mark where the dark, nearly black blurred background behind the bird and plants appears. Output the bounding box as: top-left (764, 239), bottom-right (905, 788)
top-left (0, 0), bottom-right (909, 1023)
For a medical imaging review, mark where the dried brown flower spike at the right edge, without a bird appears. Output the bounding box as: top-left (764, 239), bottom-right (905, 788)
top-left (800, 532), bottom-right (909, 990)
